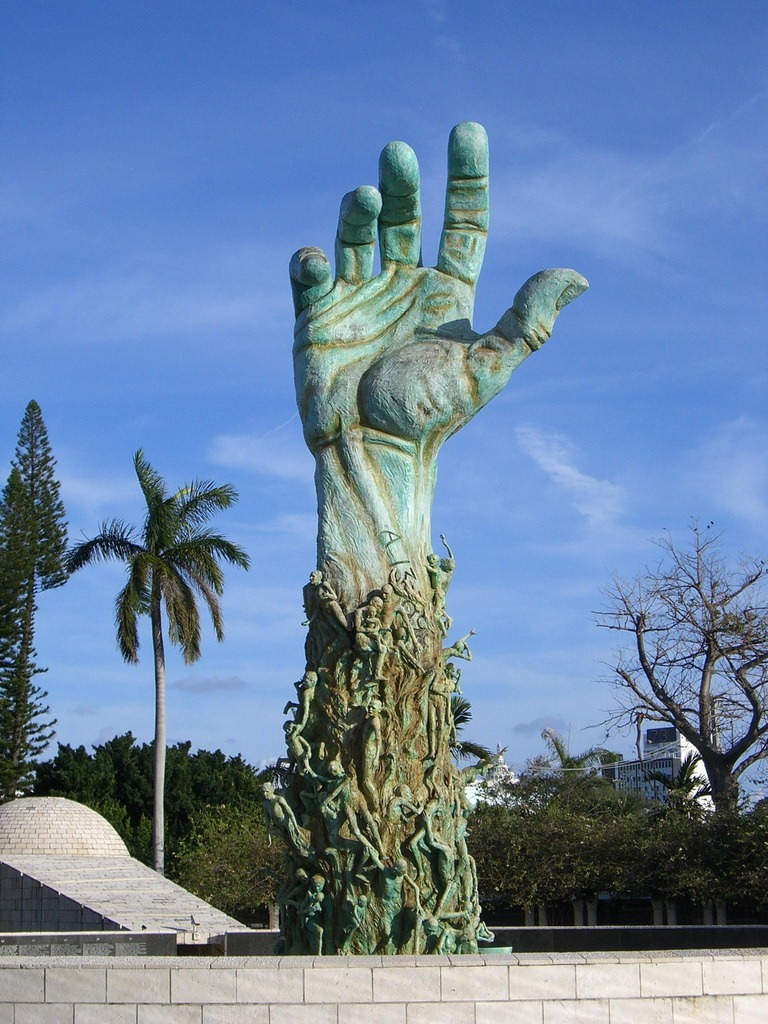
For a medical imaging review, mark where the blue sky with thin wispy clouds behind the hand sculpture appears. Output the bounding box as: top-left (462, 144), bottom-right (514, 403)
top-left (0, 0), bottom-right (768, 764)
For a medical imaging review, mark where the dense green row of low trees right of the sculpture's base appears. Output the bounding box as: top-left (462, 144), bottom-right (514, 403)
top-left (469, 737), bottom-right (768, 925)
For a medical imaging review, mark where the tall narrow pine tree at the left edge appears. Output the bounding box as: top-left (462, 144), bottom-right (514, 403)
top-left (0, 401), bottom-right (67, 800)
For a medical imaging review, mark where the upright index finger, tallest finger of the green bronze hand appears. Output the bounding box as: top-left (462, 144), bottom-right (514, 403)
top-left (437, 121), bottom-right (488, 287)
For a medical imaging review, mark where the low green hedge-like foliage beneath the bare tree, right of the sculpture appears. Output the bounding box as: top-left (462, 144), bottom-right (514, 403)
top-left (468, 737), bottom-right (768, 913)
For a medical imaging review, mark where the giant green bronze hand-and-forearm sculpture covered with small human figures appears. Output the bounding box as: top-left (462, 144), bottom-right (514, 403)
top-left (265, 123), bottom-right (587, 953)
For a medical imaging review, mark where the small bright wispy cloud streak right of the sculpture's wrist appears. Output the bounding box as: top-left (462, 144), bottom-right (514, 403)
top-left (515, 427), bottom-right (624, 526)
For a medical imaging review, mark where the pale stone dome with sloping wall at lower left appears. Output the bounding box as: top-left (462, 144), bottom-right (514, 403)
top-left (0, 797), bottom-right (248, 943)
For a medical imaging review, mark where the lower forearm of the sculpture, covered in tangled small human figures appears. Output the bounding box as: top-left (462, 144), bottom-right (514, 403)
top-left (265, 571), bottom-right (493, 954)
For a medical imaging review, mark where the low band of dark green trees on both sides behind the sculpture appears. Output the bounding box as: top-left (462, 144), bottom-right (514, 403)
top-left (34, 732), bottom-right (768, 927)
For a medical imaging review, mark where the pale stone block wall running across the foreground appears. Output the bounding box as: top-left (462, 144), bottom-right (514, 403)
top-left (0, 949), bottom-right (768, 1024)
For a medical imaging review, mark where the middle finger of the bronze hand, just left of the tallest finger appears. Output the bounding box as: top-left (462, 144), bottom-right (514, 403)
top-left (379, 142), bottom-right (421, 267)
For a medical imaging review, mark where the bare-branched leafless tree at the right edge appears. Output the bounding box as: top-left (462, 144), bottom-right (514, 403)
top-left (598, 524), bottom-right (768, 812)
